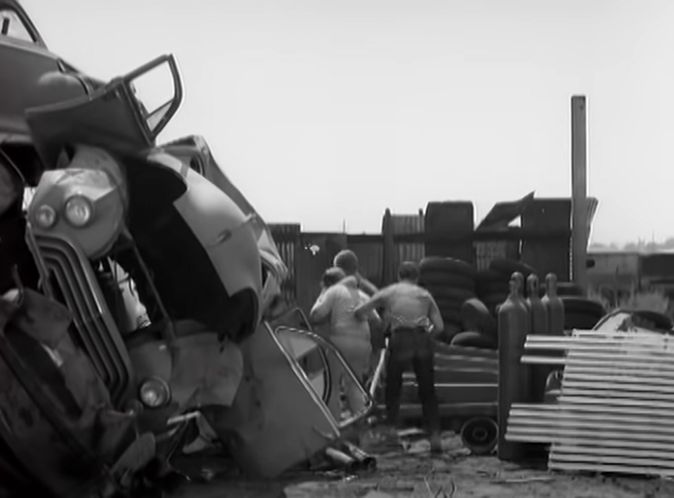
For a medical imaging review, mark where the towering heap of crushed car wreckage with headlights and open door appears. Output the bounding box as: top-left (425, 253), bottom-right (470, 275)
top-left (0, 1), bottom-right (372, 496)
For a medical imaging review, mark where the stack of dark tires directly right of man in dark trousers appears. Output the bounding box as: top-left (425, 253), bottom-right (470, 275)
top-left (419, 256), bottom-right (476, 341)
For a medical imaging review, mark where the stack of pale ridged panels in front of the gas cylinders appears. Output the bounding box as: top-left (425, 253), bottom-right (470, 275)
top-left (506, 331), bottom-right (674, 476)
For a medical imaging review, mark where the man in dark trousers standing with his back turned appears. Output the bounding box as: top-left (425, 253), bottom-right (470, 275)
top-left (355, 261), bottom-right (444, 453)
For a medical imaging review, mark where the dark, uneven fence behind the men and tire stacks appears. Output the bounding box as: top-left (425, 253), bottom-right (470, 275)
top-left (270, 199), bottom-right (571, 310)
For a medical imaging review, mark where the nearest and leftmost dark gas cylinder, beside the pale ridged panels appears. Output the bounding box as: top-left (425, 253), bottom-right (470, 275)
top-left (498, 276), bottom-right (529, 461)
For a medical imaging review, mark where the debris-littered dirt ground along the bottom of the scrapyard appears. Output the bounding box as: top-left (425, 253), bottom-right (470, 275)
top-left (171, 430), bottom-right (674, 498)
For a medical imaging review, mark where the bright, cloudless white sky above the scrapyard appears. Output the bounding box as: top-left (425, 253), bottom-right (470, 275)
top-left (22, 0), bottom-right (674, 243)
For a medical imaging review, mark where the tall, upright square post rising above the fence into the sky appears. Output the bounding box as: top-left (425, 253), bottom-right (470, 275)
top-left (571, 95), bottom-right (588, 291)
